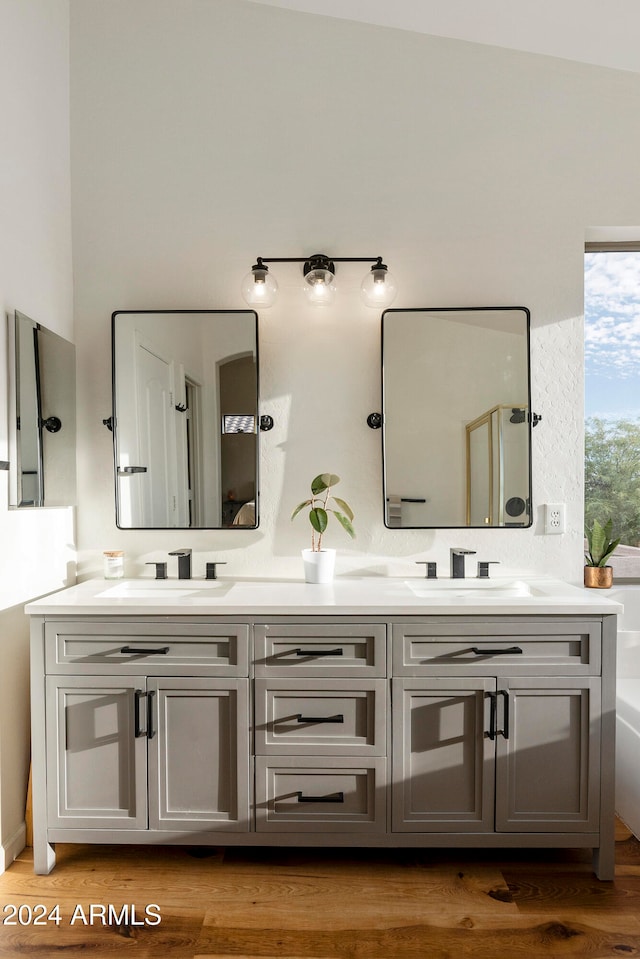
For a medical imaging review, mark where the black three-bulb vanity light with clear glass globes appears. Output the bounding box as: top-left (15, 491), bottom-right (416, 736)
top-left (242, 253), bottom-right (398, 310)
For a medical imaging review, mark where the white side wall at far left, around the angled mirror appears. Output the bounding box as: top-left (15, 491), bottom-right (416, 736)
top-left (0, 0), bottom-right (75, 872)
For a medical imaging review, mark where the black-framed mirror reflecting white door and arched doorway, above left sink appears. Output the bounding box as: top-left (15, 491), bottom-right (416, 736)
top-left (111, 310), bottom-right (258, 529)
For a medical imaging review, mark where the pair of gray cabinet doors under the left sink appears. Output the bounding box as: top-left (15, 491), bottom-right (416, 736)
top-left (46, 676), bottom-right (249, 830)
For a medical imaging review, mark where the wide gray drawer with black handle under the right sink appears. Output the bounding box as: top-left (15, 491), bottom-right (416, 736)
top-left (391, 616), bottom-right (602, 676)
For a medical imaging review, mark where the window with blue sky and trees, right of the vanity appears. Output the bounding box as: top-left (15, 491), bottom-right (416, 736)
top-left (584, 243), bottom-right (640, 580)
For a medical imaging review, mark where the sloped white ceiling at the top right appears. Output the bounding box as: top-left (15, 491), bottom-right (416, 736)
top-left (252, 0), bottom-right (640, 72)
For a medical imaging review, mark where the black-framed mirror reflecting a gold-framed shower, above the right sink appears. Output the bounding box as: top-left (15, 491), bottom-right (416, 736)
top-left (382, 307), bottom-right (532, 529)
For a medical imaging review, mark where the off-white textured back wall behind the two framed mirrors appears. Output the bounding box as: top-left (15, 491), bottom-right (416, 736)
top-left (71, 0), bottom-right (640, 581)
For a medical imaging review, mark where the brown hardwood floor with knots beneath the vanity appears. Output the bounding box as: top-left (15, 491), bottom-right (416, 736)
top-left (0, 824), bottom-right (640, 959)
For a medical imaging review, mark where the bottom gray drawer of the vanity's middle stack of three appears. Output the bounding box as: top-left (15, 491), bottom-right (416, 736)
top-left (256, 756), bottom-right (386, 833)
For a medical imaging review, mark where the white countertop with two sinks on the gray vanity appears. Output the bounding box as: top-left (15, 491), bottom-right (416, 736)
top-left (25, 576), bottom-right (623, 616)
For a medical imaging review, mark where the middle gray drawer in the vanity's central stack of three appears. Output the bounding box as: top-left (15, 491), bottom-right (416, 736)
top-left (255, 677), bottom-right (387, 756)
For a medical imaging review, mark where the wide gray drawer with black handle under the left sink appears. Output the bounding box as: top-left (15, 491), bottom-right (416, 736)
top-left (45, 620), bottom-right (249, 676)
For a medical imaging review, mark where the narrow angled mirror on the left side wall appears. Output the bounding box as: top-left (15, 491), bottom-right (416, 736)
top-left (7, 310), bottom-right (76, 508)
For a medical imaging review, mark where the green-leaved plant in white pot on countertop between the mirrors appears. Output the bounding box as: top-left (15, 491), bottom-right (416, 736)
top-left (291, 473), bottom-right (356, 583)
